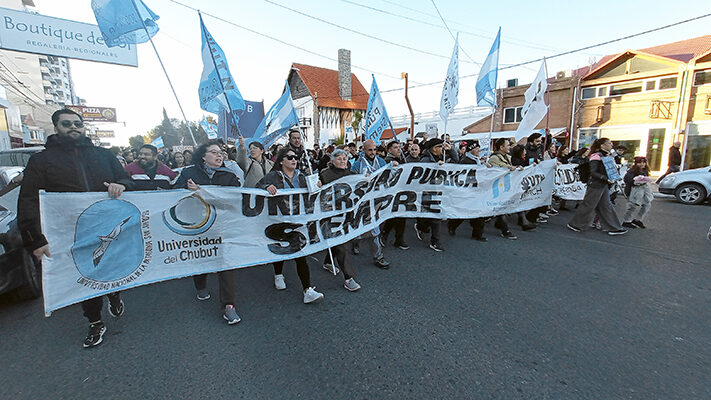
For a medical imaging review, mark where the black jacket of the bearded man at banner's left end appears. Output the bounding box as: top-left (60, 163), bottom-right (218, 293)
top-left (17, 134), bottom-right (133, 251)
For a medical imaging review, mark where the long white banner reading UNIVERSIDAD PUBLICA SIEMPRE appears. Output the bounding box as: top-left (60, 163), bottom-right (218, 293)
top-left (40, 161), bottom-right (555, 314)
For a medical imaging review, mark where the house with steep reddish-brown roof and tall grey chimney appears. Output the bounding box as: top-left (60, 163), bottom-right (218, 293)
top-left (287, 49), bottom-right (368, 148)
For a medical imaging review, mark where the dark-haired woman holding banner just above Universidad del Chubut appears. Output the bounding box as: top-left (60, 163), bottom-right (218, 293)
top-left (174, 140), bottom-right (241, 325)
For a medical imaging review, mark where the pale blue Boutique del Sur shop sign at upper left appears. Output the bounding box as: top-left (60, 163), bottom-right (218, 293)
top-left (0, 8), bottom-right (138, 66)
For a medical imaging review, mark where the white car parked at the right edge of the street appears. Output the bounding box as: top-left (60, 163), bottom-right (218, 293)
top-left (659, 166), bottom-right (711, 204)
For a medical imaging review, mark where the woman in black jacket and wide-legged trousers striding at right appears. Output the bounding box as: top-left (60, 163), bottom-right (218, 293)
top-left (568, 138), bottom-right (627, 235)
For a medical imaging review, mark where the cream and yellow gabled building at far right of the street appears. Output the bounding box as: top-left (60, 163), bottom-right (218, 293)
top-left (574, 35), bottom-right (711, 171)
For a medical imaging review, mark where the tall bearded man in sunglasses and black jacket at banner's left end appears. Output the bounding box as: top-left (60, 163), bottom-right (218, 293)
top-left (17, 108), bottom-right (133, 348)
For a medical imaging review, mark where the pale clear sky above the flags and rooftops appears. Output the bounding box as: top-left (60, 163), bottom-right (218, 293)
top-left (27, 0), bottom-right (711, 145)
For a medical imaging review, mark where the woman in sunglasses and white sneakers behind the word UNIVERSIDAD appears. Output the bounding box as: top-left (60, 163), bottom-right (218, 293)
top-left (257, 147), bottom-right (323, 304)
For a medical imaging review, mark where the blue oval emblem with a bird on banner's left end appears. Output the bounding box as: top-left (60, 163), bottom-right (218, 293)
top-left (72, 199), bottom-right (143, 282)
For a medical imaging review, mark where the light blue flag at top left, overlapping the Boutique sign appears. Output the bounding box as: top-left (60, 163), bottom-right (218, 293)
top-left (91, 0), bottom-right (160, 47)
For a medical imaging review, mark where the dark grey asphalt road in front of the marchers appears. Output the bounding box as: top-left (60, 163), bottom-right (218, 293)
top-left (0, 199), bottom-right (711, 399)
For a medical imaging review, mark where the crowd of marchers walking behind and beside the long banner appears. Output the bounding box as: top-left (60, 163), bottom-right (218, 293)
top-left (13, 109), bottom-right (652, 347)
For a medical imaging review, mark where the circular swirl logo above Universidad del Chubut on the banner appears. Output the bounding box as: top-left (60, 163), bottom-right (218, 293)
top-left (163, 193), bottom-right (217, 235)
